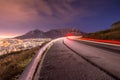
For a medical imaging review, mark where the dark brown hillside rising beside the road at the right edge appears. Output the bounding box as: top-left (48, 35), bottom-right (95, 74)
top-left (84, 21), bottom-right (120, 40)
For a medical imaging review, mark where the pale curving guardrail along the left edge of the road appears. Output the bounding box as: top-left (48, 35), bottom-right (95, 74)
top-left (19, 38), bottom-right (63, 80)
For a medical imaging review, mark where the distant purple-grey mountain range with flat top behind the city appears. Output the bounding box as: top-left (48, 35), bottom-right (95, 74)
top-left (16, 28), bottom-right (84, 39)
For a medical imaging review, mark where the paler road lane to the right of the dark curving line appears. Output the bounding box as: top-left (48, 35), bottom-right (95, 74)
top-left (64, 39), bottom-right (120, 80)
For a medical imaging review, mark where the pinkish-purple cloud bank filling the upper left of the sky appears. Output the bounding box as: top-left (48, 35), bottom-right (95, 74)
top-left (0, 0), bottom-right (97, 24)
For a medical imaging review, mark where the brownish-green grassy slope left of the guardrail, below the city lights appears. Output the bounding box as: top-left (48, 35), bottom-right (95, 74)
top-left (0, 47), bottom-right (40, 80)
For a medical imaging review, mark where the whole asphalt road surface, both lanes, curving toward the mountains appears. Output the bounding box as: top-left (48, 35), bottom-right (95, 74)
top-left (34, 39), bottom-right (120, 80)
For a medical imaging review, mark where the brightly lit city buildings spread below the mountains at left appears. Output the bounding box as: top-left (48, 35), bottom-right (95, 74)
top-left (0, 39), bottom-right (50, 55)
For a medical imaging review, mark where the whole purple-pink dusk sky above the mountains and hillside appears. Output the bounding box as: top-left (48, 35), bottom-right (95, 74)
top-left (0, 0), bottom-right (120, 38)
